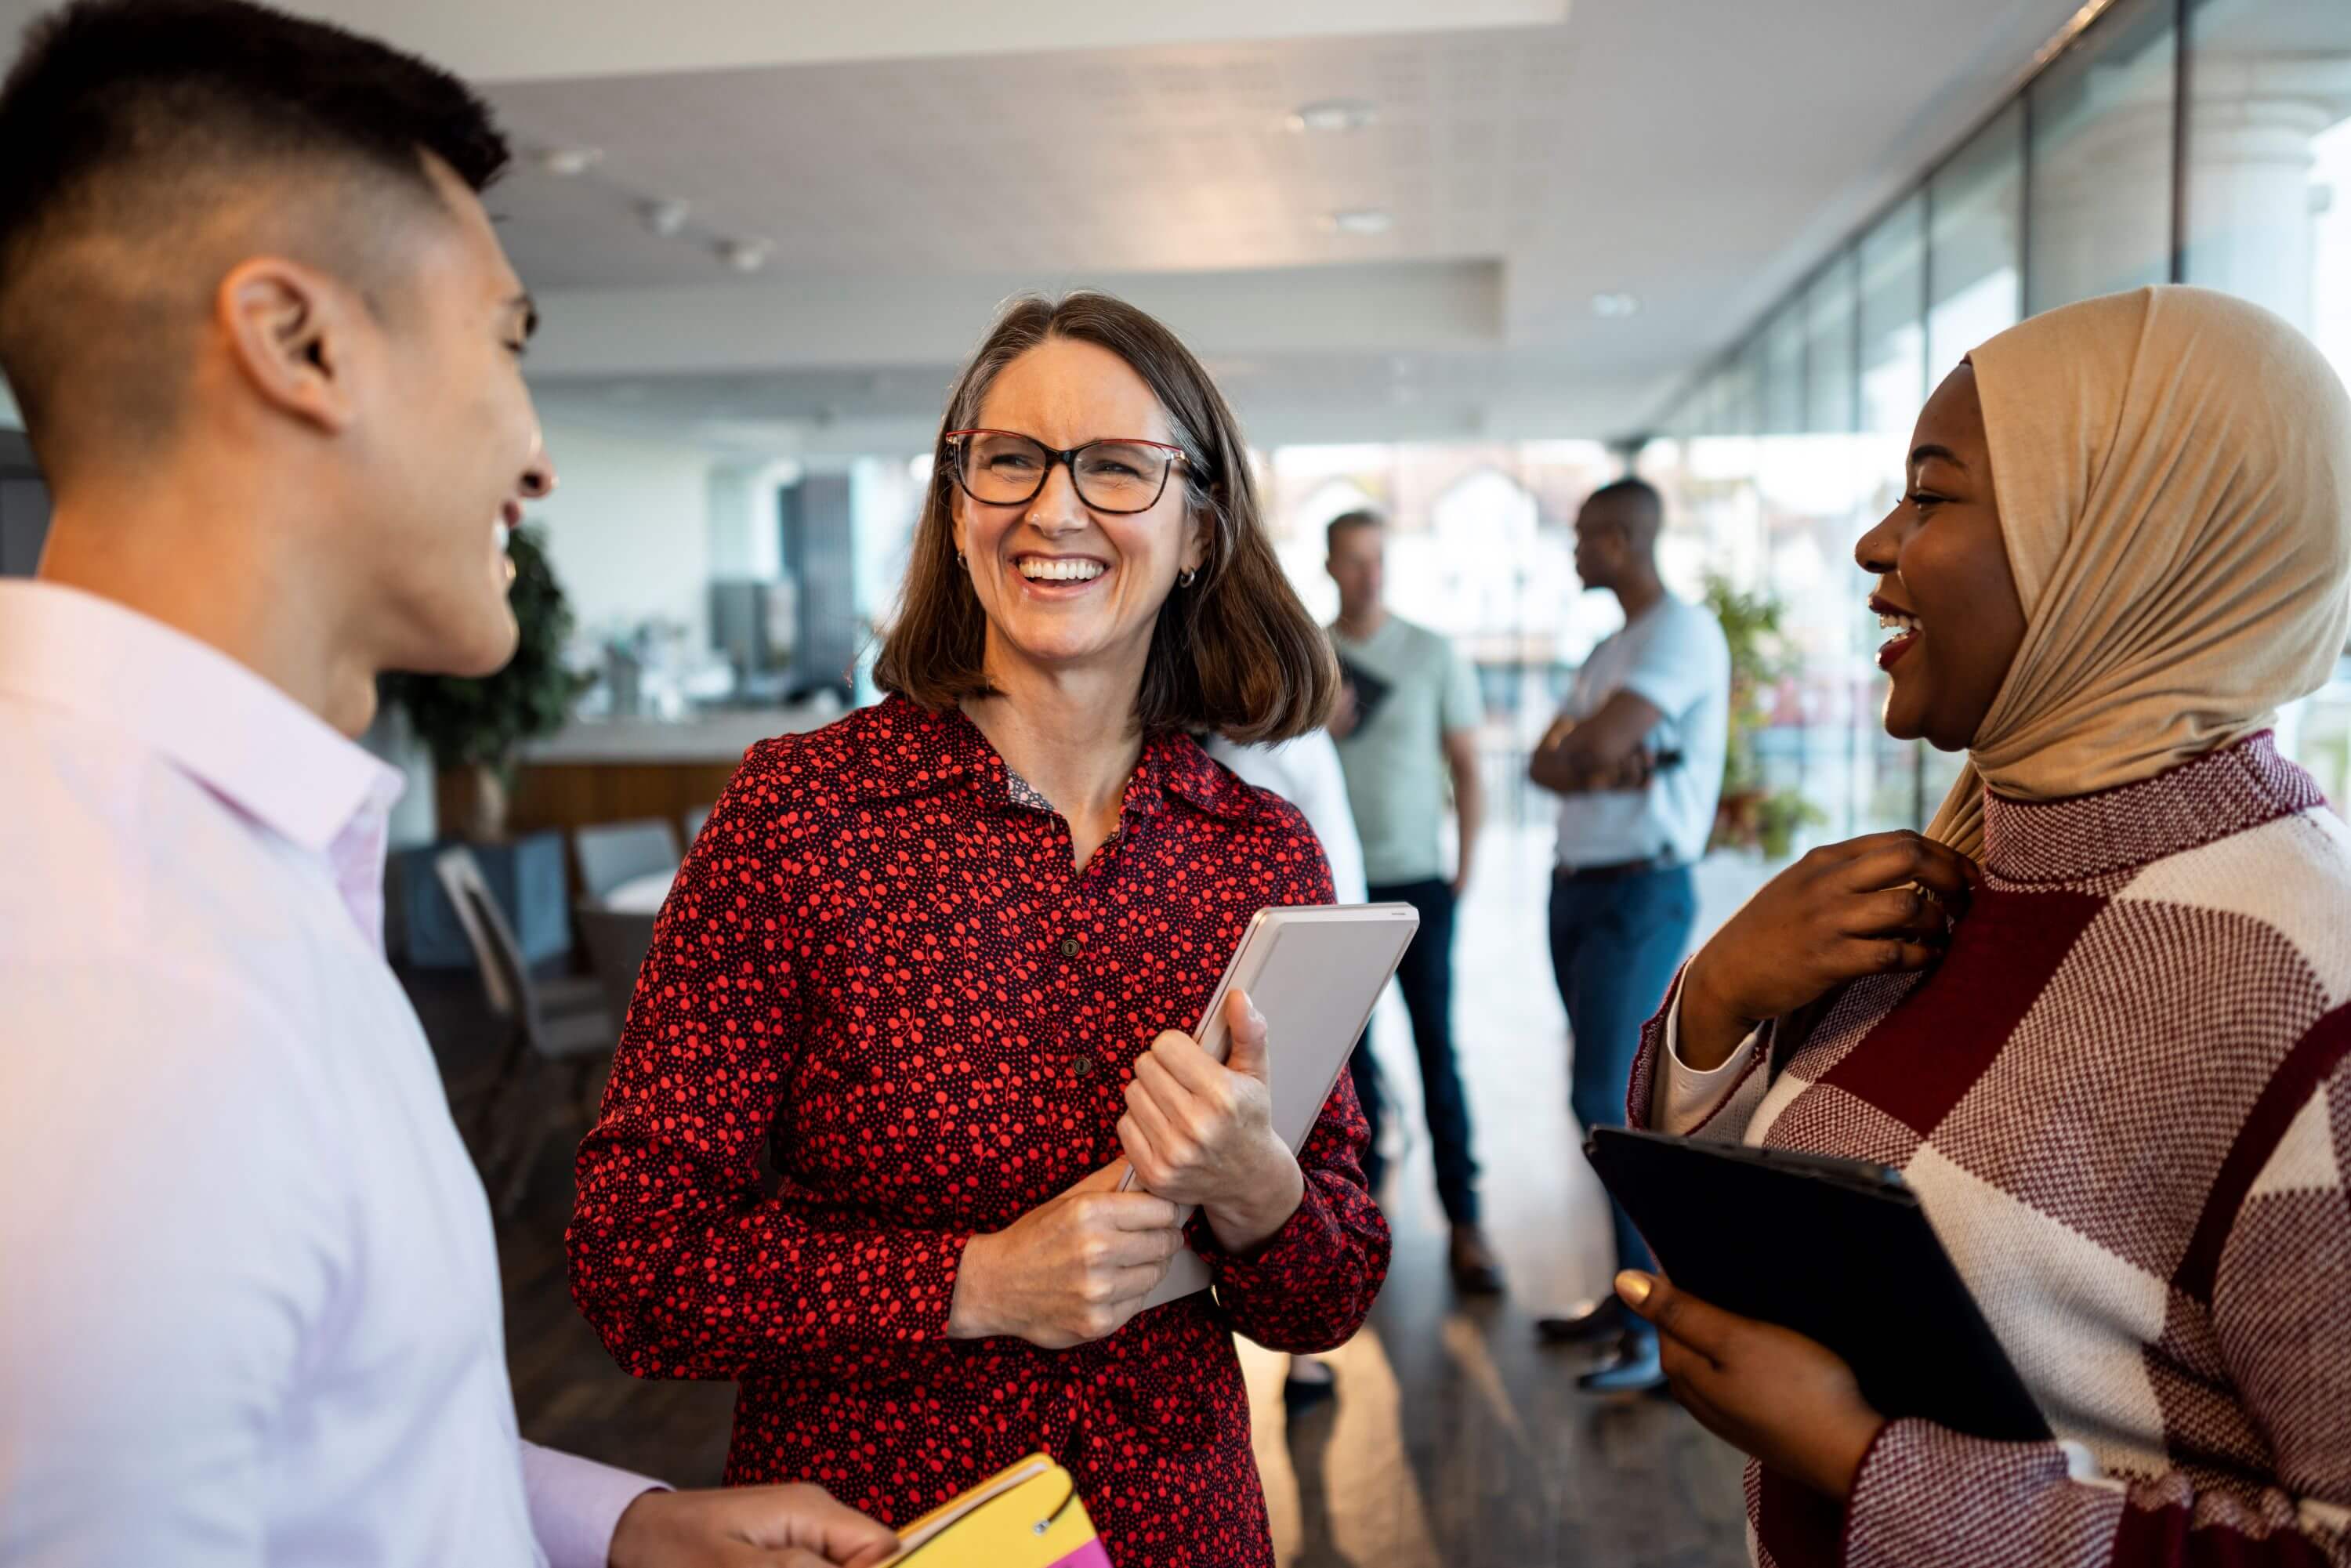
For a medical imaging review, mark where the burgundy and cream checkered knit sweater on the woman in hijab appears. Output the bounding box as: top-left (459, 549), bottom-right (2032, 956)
top-left (1632, 736), bottom-right (2351, 1568)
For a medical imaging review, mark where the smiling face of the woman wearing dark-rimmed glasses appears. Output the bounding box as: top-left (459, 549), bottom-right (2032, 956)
top-left (955, 339), bottom-right (1206, 686)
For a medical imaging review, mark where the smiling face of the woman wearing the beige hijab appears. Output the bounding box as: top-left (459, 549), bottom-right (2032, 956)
top-left (1853, 364), bottom-right (2024, 752)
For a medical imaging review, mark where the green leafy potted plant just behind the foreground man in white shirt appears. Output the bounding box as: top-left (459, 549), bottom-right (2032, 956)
top-left (381, 527), bottom-right (592, 844)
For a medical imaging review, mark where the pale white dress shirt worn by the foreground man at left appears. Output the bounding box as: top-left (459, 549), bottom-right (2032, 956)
top-left (0, 583), bottom-right (654, 1568)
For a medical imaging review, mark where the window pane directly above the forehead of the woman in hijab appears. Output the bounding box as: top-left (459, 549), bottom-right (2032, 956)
top-left (1925, 99), bottom-right (2024, 381)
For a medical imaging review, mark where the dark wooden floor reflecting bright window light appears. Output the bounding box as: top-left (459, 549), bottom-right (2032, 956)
top-left (411, 835), bottom-right (1747, 1568)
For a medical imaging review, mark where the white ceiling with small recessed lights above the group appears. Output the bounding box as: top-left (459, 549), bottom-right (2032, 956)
top-left (0, 0), bottom-right (2081, 451)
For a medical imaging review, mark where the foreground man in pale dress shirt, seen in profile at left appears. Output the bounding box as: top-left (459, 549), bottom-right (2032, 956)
top-left (0, 0), bottom-right (893, 1568)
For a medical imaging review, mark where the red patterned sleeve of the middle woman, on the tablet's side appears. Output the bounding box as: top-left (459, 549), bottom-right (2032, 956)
top-left (1187, 813), bottom-right (1389, 1354)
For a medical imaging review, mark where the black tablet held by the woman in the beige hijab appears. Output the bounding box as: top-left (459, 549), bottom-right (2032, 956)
top-left (1585, 1126), bottom-right (2050, 1441)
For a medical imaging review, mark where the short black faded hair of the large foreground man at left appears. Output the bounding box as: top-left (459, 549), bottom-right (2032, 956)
top-left (0, 0), bottom-right (508, 461)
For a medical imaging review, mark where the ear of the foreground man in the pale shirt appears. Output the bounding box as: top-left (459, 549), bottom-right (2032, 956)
top-left (214, 256), bottom-right (362, 435)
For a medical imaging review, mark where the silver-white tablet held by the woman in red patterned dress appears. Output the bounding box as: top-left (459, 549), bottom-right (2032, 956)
top-left (1128, 903), bottom-right (1420, 1307)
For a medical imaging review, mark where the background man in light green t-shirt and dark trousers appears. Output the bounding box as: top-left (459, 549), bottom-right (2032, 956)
top-left (1331, 512), bottom-right (1502, 1295)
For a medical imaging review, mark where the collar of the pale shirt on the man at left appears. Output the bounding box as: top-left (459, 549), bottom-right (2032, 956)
top-left (0, 581), bottom-right (404, 853)
